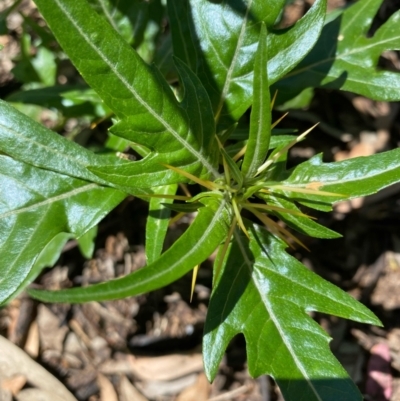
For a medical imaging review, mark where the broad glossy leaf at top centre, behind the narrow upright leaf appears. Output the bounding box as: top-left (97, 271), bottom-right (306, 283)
top-left (168, 0), bottom-right (326, 125)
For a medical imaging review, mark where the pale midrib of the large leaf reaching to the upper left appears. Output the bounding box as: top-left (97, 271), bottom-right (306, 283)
top-left (54, 0), bottom-right (219, 177)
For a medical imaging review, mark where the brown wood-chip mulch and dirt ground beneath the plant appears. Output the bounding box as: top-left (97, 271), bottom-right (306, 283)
top-left (0, 0), bottom-right (400, 401)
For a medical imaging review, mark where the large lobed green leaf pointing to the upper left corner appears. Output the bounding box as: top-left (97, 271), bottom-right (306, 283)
top-left (36, 0), bottom-right (219, 187)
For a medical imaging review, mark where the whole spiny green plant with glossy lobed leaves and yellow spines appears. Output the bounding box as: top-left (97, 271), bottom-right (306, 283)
top-left (0, 0), bottom-right (400, 401)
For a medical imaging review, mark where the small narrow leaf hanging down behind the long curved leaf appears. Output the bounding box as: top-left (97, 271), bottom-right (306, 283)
top-left (146, 184), bottom-right (177, 265)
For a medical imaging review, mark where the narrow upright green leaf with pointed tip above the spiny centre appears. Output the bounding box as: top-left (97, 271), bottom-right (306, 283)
top-left (242, 24), bottom-right (271, 178)
